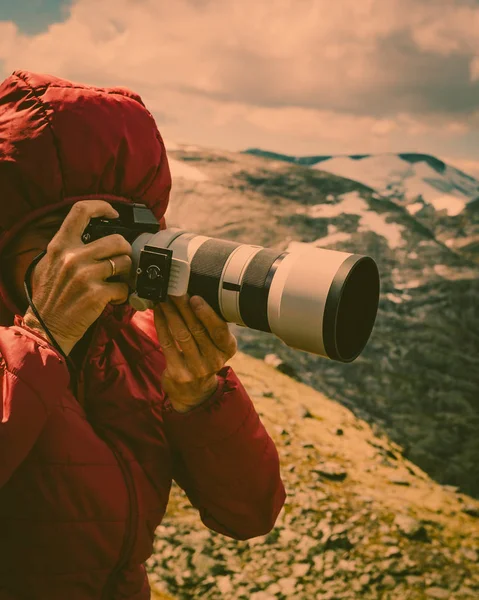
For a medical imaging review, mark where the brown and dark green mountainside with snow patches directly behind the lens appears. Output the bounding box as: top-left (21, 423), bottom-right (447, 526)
top-left (166, 145), bottom-right (479, 497)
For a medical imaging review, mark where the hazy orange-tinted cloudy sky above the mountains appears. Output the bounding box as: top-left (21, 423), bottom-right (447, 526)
top-left (0, 0), bottom-right (479, 178)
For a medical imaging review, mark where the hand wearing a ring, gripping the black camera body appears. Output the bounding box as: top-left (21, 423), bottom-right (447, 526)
top-left (24, 200), bottom-right (133, 356)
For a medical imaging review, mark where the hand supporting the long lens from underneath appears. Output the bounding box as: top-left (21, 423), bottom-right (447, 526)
top-left (153, 294), bottom-right (238, 412)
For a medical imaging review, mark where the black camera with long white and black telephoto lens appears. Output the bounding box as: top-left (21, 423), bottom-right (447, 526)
top-left (82, 202), bottom-right (380, 363)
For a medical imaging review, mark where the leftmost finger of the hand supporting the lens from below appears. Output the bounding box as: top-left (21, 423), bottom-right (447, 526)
top-left (161, 297), bottom-right (213, 377)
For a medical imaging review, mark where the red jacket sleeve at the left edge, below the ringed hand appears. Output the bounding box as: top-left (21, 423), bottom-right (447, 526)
top-left (0, 326), bottom-right (70, 489)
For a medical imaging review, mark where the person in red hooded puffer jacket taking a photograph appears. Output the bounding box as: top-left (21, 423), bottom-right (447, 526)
top-left (0, 70), bottom-right (286, 600)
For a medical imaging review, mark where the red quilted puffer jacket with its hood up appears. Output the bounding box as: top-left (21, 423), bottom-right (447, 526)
top-left (0, 71), bottom-right (285, 600)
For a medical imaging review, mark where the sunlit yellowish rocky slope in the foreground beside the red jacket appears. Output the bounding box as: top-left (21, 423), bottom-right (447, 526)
top-left (146, 352), bottom-right (479, 600)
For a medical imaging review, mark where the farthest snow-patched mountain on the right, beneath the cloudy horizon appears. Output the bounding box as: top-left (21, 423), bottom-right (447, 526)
top-left (245, 148), bottom-right (479, 262)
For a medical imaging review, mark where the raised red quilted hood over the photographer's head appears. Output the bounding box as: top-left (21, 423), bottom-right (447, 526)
top-left (0, 71), bottom-right (171, 332)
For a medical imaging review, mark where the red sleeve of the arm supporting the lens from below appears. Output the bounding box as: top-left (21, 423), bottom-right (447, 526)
top-left (163, 366), bottom-right (286, 540)
